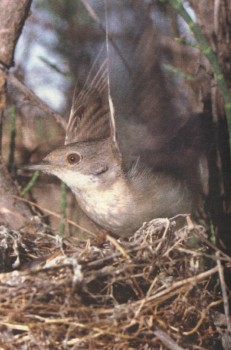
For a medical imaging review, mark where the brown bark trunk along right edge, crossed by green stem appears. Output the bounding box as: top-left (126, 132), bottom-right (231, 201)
top-left (190, 0), bottom-right (231, 251)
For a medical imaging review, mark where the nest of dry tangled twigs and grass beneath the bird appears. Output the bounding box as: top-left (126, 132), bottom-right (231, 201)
top-left (0, 218), bottom-right (230, 350)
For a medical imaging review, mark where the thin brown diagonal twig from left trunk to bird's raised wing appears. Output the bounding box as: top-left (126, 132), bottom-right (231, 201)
top-left (9, 74), bottom-right (67, 130)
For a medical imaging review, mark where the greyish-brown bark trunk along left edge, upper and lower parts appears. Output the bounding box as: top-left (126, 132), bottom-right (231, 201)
top-left (0, 0), bottom-right (31, 229)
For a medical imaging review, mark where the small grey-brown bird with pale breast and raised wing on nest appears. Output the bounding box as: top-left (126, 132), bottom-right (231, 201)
top-left (27, 60), bottom-right (199, 237)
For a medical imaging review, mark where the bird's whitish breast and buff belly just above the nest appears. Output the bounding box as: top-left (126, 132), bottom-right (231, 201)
top-left (76, 174), bottom-right (191, 236)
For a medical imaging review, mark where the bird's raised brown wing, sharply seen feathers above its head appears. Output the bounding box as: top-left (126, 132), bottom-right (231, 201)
top-left (65, 61), bottom-right (112, 145)
